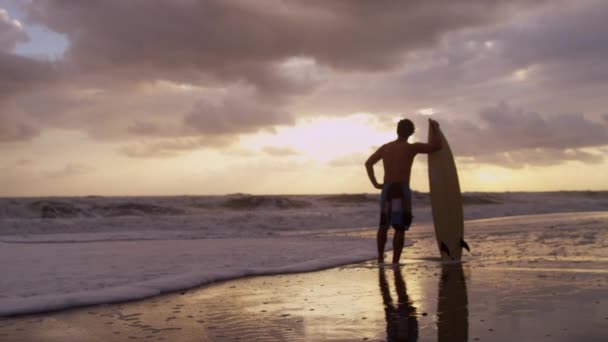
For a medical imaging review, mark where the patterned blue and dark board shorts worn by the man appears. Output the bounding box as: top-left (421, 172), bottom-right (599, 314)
top-left (380, 183), bottom-right (414, 231)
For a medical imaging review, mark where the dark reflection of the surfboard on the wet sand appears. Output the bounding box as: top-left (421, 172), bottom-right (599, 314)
top-left (437, 263), bottom-right (469, 342)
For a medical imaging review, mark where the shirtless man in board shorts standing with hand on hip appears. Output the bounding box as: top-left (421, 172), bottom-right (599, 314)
top-left (365, 119), bottom-right (441, 264)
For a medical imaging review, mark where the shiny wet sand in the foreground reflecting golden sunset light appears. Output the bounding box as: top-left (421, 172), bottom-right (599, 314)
top-left (0, 259), bottom-right (608, 341)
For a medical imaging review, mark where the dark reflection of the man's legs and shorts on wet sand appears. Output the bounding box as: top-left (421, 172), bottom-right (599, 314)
top-left (379, 267), bottom-right (418, 342)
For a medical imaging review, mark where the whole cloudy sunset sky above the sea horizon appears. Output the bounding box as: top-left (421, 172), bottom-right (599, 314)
top-left (0, 0), bottom-right (608, 196)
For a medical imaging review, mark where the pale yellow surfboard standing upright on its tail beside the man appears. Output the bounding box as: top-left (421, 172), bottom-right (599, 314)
top-left (428, 127), bottom-right (469, 260)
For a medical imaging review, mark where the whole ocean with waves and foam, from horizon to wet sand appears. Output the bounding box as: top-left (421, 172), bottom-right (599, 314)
top-left (0, 191), bottom-right (608, 315)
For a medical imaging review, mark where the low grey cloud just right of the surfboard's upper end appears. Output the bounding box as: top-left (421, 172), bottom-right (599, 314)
top-left (428, 103), bottom-right (608, 167)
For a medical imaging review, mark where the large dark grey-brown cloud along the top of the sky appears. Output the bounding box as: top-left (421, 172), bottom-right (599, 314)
top-left (25, 0), bottom-right (538, 93)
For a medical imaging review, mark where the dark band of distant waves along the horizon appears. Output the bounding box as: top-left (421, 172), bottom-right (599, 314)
top-left (0, 191), bottom-right (608, 219)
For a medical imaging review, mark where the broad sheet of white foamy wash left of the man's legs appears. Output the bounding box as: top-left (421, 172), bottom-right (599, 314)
top-left (0, 237), bottom-right (375, 315)
